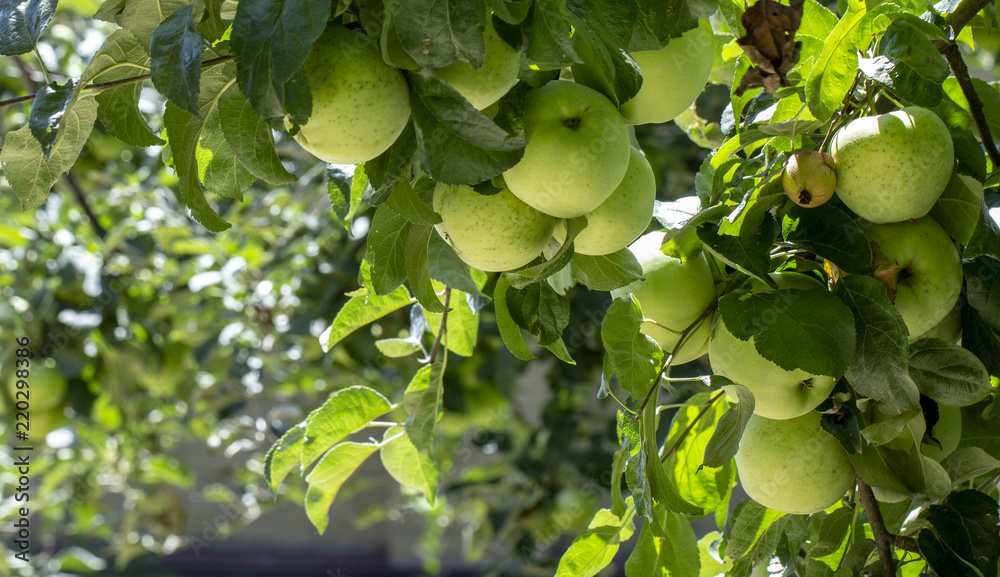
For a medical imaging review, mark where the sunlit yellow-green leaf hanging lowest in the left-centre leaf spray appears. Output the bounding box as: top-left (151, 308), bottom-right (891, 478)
top-left (305, 442), bottom-right (378, 535)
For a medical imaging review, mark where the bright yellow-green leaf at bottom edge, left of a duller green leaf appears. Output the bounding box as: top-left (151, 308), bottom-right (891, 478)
top-left (556, 509), bottom-right (633, 577)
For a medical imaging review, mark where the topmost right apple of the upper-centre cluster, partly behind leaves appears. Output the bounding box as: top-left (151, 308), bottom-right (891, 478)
top-left (573, 20), bottom-right (715, 124)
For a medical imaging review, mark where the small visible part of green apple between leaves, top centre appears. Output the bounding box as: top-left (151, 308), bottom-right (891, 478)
top-left (434, 23), bottom-right (521, 110)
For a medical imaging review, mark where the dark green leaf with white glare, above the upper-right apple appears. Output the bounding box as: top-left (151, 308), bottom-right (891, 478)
top-left (858, 18), bottom-right (950, 108)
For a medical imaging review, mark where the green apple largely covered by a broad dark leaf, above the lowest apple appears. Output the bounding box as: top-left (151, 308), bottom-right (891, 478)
top-left (708, 272), bottom-right (837, 419)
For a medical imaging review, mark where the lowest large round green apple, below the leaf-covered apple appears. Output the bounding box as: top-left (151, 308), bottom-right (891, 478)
top-left (736, 411), bottom-right (854, 515)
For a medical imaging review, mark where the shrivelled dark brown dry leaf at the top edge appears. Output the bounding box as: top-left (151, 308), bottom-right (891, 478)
top-left (736, 0), bottom-right (805, 96)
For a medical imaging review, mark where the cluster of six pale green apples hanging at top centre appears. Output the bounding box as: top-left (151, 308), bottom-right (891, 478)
top-left (289, 21), bottom-right (714, 271)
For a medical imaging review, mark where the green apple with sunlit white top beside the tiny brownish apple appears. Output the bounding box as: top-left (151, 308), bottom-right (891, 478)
top-left (830, 106), bottom-right (955, 223)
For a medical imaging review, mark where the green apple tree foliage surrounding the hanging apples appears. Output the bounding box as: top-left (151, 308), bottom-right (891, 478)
top-left (0, 0), bottom-right (1000, 576)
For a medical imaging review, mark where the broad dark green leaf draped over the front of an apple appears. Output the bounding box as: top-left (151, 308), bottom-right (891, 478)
top-left (719, 289), bottom-right (855, 377)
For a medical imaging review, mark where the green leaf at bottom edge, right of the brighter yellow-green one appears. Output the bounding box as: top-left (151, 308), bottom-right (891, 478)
top-left (625, 511), bottom-right (701, 577)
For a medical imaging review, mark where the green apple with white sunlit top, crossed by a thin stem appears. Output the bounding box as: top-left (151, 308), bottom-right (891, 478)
top-left (611, 232), bottom-right (715, 364)
